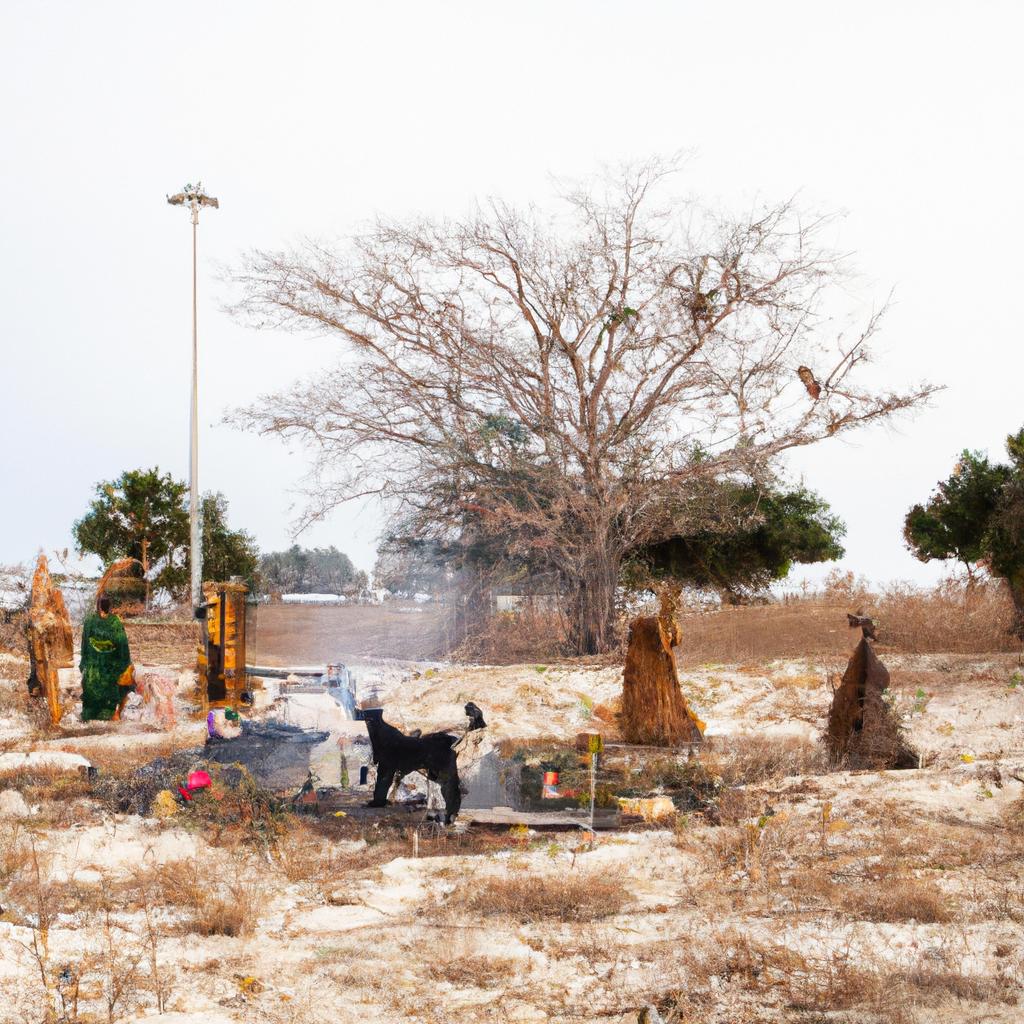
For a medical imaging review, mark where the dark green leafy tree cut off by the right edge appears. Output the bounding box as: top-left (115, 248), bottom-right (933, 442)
top-left (903, 430), bottom-right (1024, 639)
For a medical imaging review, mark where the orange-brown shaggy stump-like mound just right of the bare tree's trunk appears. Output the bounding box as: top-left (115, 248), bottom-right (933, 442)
top-left (620, 594), bottom-right (703, 746)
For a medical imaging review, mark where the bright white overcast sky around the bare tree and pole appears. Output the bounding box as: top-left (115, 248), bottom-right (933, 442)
top-left (0, 0), bottom-right (1024, 584)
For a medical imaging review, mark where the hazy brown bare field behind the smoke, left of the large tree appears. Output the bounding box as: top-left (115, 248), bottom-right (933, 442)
top-left (247, 601), bottom-right (446, 665)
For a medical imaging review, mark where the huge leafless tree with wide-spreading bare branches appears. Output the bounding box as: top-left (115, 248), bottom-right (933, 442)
top-left (233, 163), bottom-right (933, 653)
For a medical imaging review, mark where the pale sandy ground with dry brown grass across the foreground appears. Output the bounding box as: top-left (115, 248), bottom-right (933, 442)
top-left (0, 652), bottom-right (1024, 1024)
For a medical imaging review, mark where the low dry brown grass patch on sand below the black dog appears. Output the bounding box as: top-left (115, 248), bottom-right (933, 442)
top-left (444, 871), bottom-right (627, 923)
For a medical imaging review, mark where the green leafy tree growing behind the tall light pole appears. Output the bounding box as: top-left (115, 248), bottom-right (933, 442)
top-left (72, 467), bottom-right (259, 600)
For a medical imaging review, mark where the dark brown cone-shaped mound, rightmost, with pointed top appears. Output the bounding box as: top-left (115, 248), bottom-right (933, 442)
top-left (825, 637), bottom-right (918, 768)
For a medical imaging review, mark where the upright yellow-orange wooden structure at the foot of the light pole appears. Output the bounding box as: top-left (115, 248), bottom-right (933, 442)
top-left (199, 582), bottom-right (249, 715)
